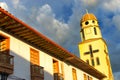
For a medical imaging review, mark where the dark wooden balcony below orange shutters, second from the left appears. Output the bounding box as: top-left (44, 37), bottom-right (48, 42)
top-left (31, 65), bottom-right (44, 80)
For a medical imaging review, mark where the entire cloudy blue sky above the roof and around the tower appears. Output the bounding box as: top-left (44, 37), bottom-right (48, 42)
top-left (0, 0), bottom-right (120, 80)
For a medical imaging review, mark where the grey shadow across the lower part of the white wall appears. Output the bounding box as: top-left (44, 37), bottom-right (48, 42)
top-left (7, 51), bottom-right (53, 80)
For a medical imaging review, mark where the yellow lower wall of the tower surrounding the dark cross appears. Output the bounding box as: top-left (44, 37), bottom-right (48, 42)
top-left (79, 34), bottom-right (113, 80)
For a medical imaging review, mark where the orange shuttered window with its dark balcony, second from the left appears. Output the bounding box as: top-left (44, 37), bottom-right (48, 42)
top-left (30, 48), bottom-right (44, 80)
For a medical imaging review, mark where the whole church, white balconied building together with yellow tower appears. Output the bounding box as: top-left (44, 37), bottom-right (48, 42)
top-left (0, 8), bottom-right (114, 80)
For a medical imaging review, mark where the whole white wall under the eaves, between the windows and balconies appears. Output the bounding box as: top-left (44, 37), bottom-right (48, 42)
top-left (0, 31), bottom-right (98, 80)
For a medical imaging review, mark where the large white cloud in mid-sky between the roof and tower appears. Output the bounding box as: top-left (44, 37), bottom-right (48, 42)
top-left (36, 4), bottom-right (69, 43)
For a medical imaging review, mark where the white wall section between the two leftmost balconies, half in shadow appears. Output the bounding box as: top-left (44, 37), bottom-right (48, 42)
top-left (0, 31), bottom-right (30, 80)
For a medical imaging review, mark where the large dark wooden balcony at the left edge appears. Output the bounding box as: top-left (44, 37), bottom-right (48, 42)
top-left (0, 52), bottom-right (14, 74)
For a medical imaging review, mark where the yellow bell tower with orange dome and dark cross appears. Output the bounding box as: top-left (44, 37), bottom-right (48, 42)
top-left (78, 13), bottom-right (114, 80)
